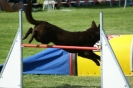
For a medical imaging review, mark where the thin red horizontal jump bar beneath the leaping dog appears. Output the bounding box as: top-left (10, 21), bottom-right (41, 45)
top-left (22, 44), bottom-right (100, 50)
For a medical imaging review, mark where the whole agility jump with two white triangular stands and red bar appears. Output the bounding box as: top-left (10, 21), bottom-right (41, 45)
top-left (0, 7), bottom-right (130, 88)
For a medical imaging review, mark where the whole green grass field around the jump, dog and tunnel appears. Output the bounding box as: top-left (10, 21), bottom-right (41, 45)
top-left (0, 5), bottom-right (133, 88)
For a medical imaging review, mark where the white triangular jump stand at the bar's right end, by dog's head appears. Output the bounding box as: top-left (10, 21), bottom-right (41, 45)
top-left (100, 12), bottom-right (130, 88)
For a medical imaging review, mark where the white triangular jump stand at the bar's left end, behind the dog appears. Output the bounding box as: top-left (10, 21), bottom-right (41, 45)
top-left (0, 10), bottom-right (23, 88)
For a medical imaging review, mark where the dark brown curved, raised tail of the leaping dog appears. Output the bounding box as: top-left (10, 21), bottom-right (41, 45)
top-left (25, 0), bottom-right (42, 25)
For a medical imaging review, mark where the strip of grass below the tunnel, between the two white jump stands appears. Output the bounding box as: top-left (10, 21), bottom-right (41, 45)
top-left (24, 75), bottom-right (100, 88)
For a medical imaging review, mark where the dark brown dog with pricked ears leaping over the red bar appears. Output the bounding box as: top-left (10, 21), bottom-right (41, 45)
top-left (23, 1), bottom-right (100, 66)
